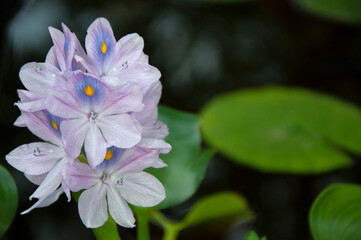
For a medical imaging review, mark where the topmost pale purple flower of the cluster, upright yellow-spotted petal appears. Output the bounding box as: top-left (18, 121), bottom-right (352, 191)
top-left (75, 18), bottom-right (161, 89)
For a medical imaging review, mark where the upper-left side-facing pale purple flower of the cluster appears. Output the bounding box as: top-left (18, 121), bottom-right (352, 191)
top-left (16, 24), bottom-right (86, 112)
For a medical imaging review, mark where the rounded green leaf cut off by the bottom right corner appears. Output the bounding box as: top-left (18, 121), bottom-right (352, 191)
top-left (310, 184), bottom-right (361, 240)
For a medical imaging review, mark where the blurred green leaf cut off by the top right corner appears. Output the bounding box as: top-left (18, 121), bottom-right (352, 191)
top-left (296, 0), bottom-right (361, 23)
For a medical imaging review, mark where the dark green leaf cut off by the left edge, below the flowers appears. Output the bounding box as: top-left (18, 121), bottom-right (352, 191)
top-left (0, 165), bottom-right (18, 237)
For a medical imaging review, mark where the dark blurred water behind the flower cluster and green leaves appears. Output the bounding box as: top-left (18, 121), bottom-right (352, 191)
top-left (0, 0), bottom-right (361, 240)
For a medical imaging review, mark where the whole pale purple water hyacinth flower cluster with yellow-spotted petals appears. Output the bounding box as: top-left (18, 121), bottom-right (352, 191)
top-left (6, 18), bottom-right (171, 228)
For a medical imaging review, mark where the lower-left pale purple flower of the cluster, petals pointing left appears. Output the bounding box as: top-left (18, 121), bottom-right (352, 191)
top-left (6, 110), bottom-right (73, 205)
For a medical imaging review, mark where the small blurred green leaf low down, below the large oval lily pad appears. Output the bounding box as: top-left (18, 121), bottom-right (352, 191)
top-left (180, 192), bottom-right (253, 228)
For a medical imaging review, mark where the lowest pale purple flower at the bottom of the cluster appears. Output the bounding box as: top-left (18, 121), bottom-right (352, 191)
top-left (62, 147), bottom-right (165, 228)
